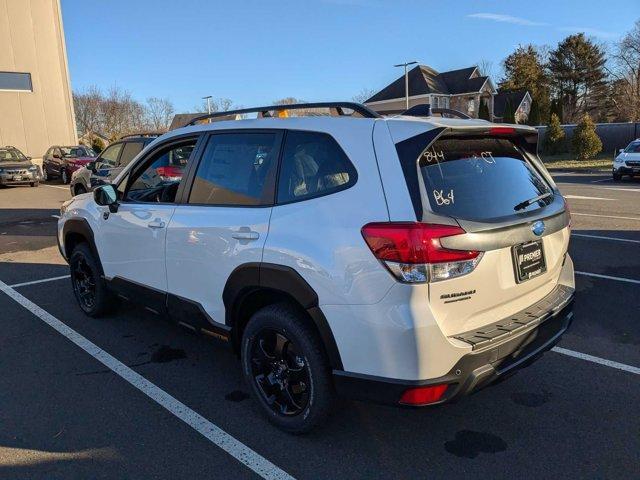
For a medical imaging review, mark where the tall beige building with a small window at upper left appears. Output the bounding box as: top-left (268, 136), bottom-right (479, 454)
top-left (0, 0), bottom-right (77, 157)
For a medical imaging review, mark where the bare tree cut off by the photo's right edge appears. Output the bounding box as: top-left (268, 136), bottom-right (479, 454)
top-left (610, 20), bottom-right (640, 122)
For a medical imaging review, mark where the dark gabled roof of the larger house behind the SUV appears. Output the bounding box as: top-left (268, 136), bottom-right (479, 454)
top-left (364, 65), bottom-right (496, 104)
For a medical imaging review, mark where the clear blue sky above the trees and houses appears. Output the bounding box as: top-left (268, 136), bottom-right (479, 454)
top-left (62, 0), bottom-right (640, 112)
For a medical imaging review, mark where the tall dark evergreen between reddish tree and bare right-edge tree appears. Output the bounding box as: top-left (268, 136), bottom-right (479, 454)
top-left (548, 33), bottom-right (608, 122)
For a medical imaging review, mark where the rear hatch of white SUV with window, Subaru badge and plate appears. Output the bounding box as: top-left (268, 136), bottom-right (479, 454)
top-left (396, 127), bottom-right (569, 336)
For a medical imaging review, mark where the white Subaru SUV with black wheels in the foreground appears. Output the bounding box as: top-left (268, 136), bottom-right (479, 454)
top-left (58, 103), bottom-right (575, 433)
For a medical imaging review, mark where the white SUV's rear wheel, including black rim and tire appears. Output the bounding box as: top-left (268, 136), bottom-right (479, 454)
top-left (240, 302), bottom-right (335, 434)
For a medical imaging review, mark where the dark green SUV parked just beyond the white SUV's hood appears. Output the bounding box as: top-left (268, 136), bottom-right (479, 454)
top-left (70, 133), bottom-right (160, 196)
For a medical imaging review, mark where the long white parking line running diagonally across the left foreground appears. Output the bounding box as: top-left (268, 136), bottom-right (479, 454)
top-left (0, 281), bottom-right (293, 480)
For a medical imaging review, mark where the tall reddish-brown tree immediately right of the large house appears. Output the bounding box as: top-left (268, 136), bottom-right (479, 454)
top-left (499, 45), bottom-right (549, 119)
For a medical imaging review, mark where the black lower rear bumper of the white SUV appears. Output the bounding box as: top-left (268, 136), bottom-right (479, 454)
top-left (333, 293), bottom-right (573, 405)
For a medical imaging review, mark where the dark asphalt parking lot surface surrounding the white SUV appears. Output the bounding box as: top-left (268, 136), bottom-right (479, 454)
top-left (0, 173), bottom-right (640, 479)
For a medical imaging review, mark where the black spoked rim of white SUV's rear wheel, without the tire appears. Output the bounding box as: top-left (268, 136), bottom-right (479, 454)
top-left (251, 328), bottom-right (311, 416)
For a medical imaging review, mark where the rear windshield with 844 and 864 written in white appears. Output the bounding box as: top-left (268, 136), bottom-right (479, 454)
top-left (398, 132), bottom-right (553, 221)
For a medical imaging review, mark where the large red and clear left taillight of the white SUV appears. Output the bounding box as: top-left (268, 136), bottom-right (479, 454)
top-left (362, 222), bottom-right (482, 283)
